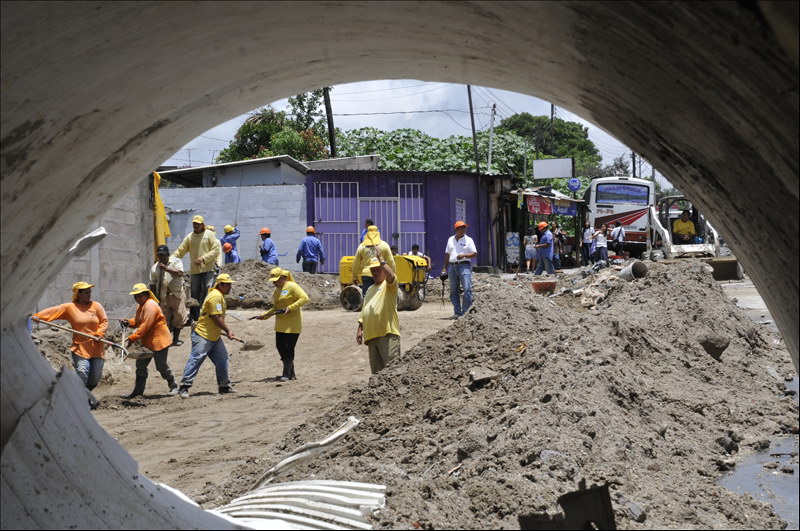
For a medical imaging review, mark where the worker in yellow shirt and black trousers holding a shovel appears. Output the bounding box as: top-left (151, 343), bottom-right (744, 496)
top-left (256, 267), bottom-right (308, 382)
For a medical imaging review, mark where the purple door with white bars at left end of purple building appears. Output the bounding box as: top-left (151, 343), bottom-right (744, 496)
top-left (314, 182), bottom-right (361, 273)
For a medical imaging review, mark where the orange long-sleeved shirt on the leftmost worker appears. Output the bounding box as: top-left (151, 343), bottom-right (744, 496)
top-left (33, 301), bottom-right (108, 359)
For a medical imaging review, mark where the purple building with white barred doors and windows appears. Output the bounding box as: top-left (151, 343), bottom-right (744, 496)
top-left (306, 170), bottom-right (508, 273)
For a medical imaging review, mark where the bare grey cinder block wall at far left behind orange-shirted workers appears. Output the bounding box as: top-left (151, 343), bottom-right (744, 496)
top-left (30, 179), bottom-right (153, 324)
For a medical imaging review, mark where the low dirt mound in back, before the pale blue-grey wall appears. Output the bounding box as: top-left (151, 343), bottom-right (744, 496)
top-left (222, 260), bottom-right (339, 310)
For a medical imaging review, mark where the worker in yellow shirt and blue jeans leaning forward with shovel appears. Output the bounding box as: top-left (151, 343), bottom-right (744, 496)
top-left (178, 273), bottom-right (237, 398)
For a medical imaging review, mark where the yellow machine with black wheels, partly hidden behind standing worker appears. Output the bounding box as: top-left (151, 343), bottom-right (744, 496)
top-left (339, 254), bottom-right (428, 312)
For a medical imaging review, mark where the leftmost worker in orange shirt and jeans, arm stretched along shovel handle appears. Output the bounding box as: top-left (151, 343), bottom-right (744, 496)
top-left (31, 282), bottom-right (108, 391)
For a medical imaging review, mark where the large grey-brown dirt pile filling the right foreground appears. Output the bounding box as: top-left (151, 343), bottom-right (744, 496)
top-left (203, 261), bottom-right (798, 529)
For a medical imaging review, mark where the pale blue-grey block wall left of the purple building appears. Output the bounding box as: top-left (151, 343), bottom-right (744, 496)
top-left (161, 185), bottom-right (306, 272)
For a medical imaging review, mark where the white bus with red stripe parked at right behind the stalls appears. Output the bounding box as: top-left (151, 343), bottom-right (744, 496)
top-left (584, 177), bottom-right (656, 257)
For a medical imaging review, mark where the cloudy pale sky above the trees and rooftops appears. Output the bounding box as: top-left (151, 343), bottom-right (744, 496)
top-left (164, 79), bottom-right (668, 186)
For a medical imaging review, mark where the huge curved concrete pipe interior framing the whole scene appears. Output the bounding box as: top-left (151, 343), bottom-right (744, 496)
top-left (0, 1), bottom-right (800, 528)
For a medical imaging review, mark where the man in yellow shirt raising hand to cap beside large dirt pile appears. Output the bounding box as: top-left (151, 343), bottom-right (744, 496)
top-left (356, 258), bottom-right (400, 374)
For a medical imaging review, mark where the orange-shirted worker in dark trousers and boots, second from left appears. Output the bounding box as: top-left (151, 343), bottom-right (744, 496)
top-left (119, 284), bottom-right (178, 398)
